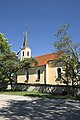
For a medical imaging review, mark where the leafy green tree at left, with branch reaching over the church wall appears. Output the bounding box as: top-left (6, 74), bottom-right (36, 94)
top-left (0, 33), bottom-right (37, 89)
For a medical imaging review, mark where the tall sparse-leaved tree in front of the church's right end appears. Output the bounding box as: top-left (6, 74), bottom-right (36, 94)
top-left (53, 24), bottom-right (80, 86)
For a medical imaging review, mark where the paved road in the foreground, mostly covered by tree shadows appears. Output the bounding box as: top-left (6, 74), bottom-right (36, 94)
top-left (0, 95), bottom-right (80, 120)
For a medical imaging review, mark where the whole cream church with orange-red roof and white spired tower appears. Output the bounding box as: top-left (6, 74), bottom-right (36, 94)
top-left (17, 31), bottom-right (62, 85)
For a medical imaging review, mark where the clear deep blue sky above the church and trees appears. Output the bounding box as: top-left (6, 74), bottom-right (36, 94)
top-left (0, 0), bottom-right (80, 57)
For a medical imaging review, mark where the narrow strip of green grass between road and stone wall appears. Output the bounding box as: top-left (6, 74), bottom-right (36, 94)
top-left (0, 91), bottom-right (76, 99)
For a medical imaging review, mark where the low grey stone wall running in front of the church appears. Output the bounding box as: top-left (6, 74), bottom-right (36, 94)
top-left (13, 83), bottom-right (80, 95)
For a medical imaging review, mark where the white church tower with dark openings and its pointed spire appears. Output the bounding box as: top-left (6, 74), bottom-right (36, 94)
top-left (20, 28), bottom-right (31, 60)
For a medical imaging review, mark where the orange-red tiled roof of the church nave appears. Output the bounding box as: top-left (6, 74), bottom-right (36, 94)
top-left (35, 52), bottom-right (62, 66)
